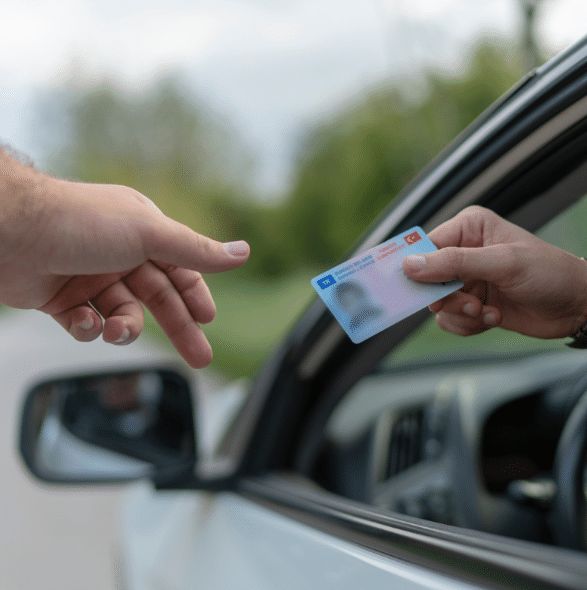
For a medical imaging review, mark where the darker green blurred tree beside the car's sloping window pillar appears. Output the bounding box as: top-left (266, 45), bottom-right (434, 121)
top-left (284, 44), bottom-right (521, 265)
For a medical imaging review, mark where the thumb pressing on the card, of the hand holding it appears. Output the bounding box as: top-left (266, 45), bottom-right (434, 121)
top-left (402, 246), bottom-right (513, 283)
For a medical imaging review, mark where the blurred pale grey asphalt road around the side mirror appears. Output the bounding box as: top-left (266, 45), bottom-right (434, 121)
top-left (0, 311), bottom-right (210, 590)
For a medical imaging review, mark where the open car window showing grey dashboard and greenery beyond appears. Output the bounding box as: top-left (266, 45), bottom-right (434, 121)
top-left (312, 197), bottom-right (587, 543)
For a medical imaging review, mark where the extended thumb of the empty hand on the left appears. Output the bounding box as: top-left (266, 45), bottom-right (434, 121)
top-left (143, 218), bottom-right (250, 273)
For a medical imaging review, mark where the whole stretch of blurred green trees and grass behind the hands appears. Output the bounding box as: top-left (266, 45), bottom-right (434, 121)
top-left (39, 44), bottom-right (521, 376)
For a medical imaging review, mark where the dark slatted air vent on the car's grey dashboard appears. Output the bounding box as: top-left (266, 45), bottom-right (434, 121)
top-left (385, 408), bottom-right (424, 479)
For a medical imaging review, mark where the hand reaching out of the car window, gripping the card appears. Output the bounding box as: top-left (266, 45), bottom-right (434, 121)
top-left (403, 207), bottom-right (587, 338)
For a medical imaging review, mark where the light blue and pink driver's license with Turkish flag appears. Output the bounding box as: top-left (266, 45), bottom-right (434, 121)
top-left (311, 227), bottom-right (463, 343)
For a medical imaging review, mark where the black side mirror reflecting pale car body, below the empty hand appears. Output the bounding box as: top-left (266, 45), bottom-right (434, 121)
top-left (20, 369), bottom-right (196, 483)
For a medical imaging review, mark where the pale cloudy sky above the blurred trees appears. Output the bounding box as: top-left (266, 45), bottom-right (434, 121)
top-left (0, 0), bottom-right (587, 195)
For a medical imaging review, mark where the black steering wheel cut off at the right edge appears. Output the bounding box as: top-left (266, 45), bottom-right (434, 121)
top-left (549, 391), bottom-right (587, 551)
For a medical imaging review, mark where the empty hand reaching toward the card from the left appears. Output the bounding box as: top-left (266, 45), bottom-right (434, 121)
top-left (0, 160), bottom-right (249, 367)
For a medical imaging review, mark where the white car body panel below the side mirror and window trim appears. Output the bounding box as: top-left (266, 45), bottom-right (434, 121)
top-left (120, 484), bottom-right (478, 590)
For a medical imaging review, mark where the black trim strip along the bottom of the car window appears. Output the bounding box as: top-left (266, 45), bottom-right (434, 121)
top-left (239, 476), bottom-right (587, 590)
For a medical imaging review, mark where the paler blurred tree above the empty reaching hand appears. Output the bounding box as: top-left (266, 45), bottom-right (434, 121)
top-left (42, 80), bottom-right (252, 240)
